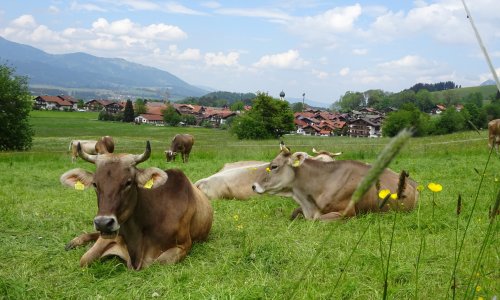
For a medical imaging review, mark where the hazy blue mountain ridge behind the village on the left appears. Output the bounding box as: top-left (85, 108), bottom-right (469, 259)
top-left (0, 37), bottom-right (209, 100)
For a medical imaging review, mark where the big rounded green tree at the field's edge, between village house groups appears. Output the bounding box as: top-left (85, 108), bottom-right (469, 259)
top-left (231, 93), bottom-right (294, 139)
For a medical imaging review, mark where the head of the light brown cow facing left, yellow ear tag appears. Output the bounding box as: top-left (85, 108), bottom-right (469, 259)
top-left (252, 145), bottom-right (309, 194)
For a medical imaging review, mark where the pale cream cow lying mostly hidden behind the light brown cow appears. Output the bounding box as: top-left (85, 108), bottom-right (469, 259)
top-left (195, 144), bottom-right (341, 200)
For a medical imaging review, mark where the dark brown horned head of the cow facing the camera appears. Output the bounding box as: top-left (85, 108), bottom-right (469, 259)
top-left (60, 141), bottom-right (168, 238)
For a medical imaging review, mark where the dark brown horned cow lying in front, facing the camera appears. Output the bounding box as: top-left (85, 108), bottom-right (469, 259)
top-left (60, 142), bottom-right (213, 270)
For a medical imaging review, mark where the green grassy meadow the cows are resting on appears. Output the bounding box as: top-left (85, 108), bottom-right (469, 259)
top-left (0, 111), bottom-right (500, 299)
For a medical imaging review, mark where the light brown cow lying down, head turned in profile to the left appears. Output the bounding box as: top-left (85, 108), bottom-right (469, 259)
top-left (252, 148), bottom-right (418, 220)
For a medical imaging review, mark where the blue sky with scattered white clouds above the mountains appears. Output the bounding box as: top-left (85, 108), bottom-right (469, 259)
top-left (0, 0), bottom-right (500, 105)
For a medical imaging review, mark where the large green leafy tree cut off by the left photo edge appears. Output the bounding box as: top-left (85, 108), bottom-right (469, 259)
top-left (0, 65), bottom-right (34, 150)
